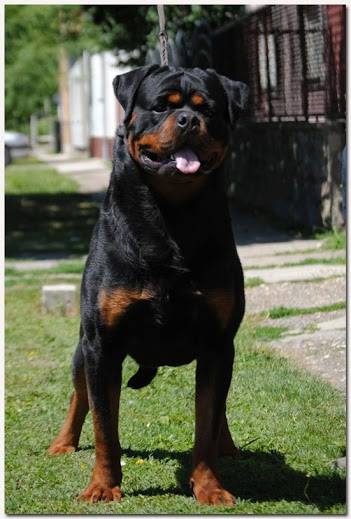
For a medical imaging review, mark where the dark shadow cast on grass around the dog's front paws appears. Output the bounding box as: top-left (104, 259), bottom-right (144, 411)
top-left (122, 449), bottom-right (346, 510)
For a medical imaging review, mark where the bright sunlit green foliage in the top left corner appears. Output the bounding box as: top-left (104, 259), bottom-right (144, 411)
top-left (5, 5), bottom-right (101, 130)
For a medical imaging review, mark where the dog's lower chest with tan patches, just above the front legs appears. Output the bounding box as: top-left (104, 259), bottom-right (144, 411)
top-left (99, 286), bottom-right (234, 366)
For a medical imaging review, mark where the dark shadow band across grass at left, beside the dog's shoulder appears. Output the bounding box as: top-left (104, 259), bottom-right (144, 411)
top-left (5, 193), bottom-right (101, 259)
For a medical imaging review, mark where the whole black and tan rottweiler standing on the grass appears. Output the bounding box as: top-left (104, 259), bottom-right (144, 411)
top-left (49, 65), bottom-right (247, 505)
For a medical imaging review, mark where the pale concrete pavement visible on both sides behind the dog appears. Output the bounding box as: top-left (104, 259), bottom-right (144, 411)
top-left (11, 150), bottom-right (346, 394)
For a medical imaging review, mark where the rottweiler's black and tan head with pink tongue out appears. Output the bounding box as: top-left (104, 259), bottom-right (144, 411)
top-left (113, 65), bottom-right (248, 178)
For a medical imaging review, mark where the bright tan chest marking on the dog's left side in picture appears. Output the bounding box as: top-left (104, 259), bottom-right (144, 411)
top-left (98, 288), bottom-right (152, 326)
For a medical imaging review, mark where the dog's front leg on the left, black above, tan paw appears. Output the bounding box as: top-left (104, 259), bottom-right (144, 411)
top-left (79, 338), bottom-right (123, 503)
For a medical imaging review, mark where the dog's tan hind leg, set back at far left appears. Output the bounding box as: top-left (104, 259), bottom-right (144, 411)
top-left (48, 342), bottom-right (89, 455)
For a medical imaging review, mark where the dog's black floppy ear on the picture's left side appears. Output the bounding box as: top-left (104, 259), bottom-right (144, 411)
top-left (112, 65), bottom-right (159, 122)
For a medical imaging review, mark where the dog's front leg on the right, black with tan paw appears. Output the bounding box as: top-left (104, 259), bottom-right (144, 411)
top-left (190, 344), bottom-right (235, 506)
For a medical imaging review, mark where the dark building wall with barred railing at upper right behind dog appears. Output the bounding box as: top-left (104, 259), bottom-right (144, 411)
top-left (212, 4), bottom-right (346, 230)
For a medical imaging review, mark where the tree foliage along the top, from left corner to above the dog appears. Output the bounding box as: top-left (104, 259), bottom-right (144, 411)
top-left (5, 4), bottom-right (243, 129)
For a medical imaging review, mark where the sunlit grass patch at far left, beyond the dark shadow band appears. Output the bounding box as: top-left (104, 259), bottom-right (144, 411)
top-left (5, 159), bottom-right (78, 195)
